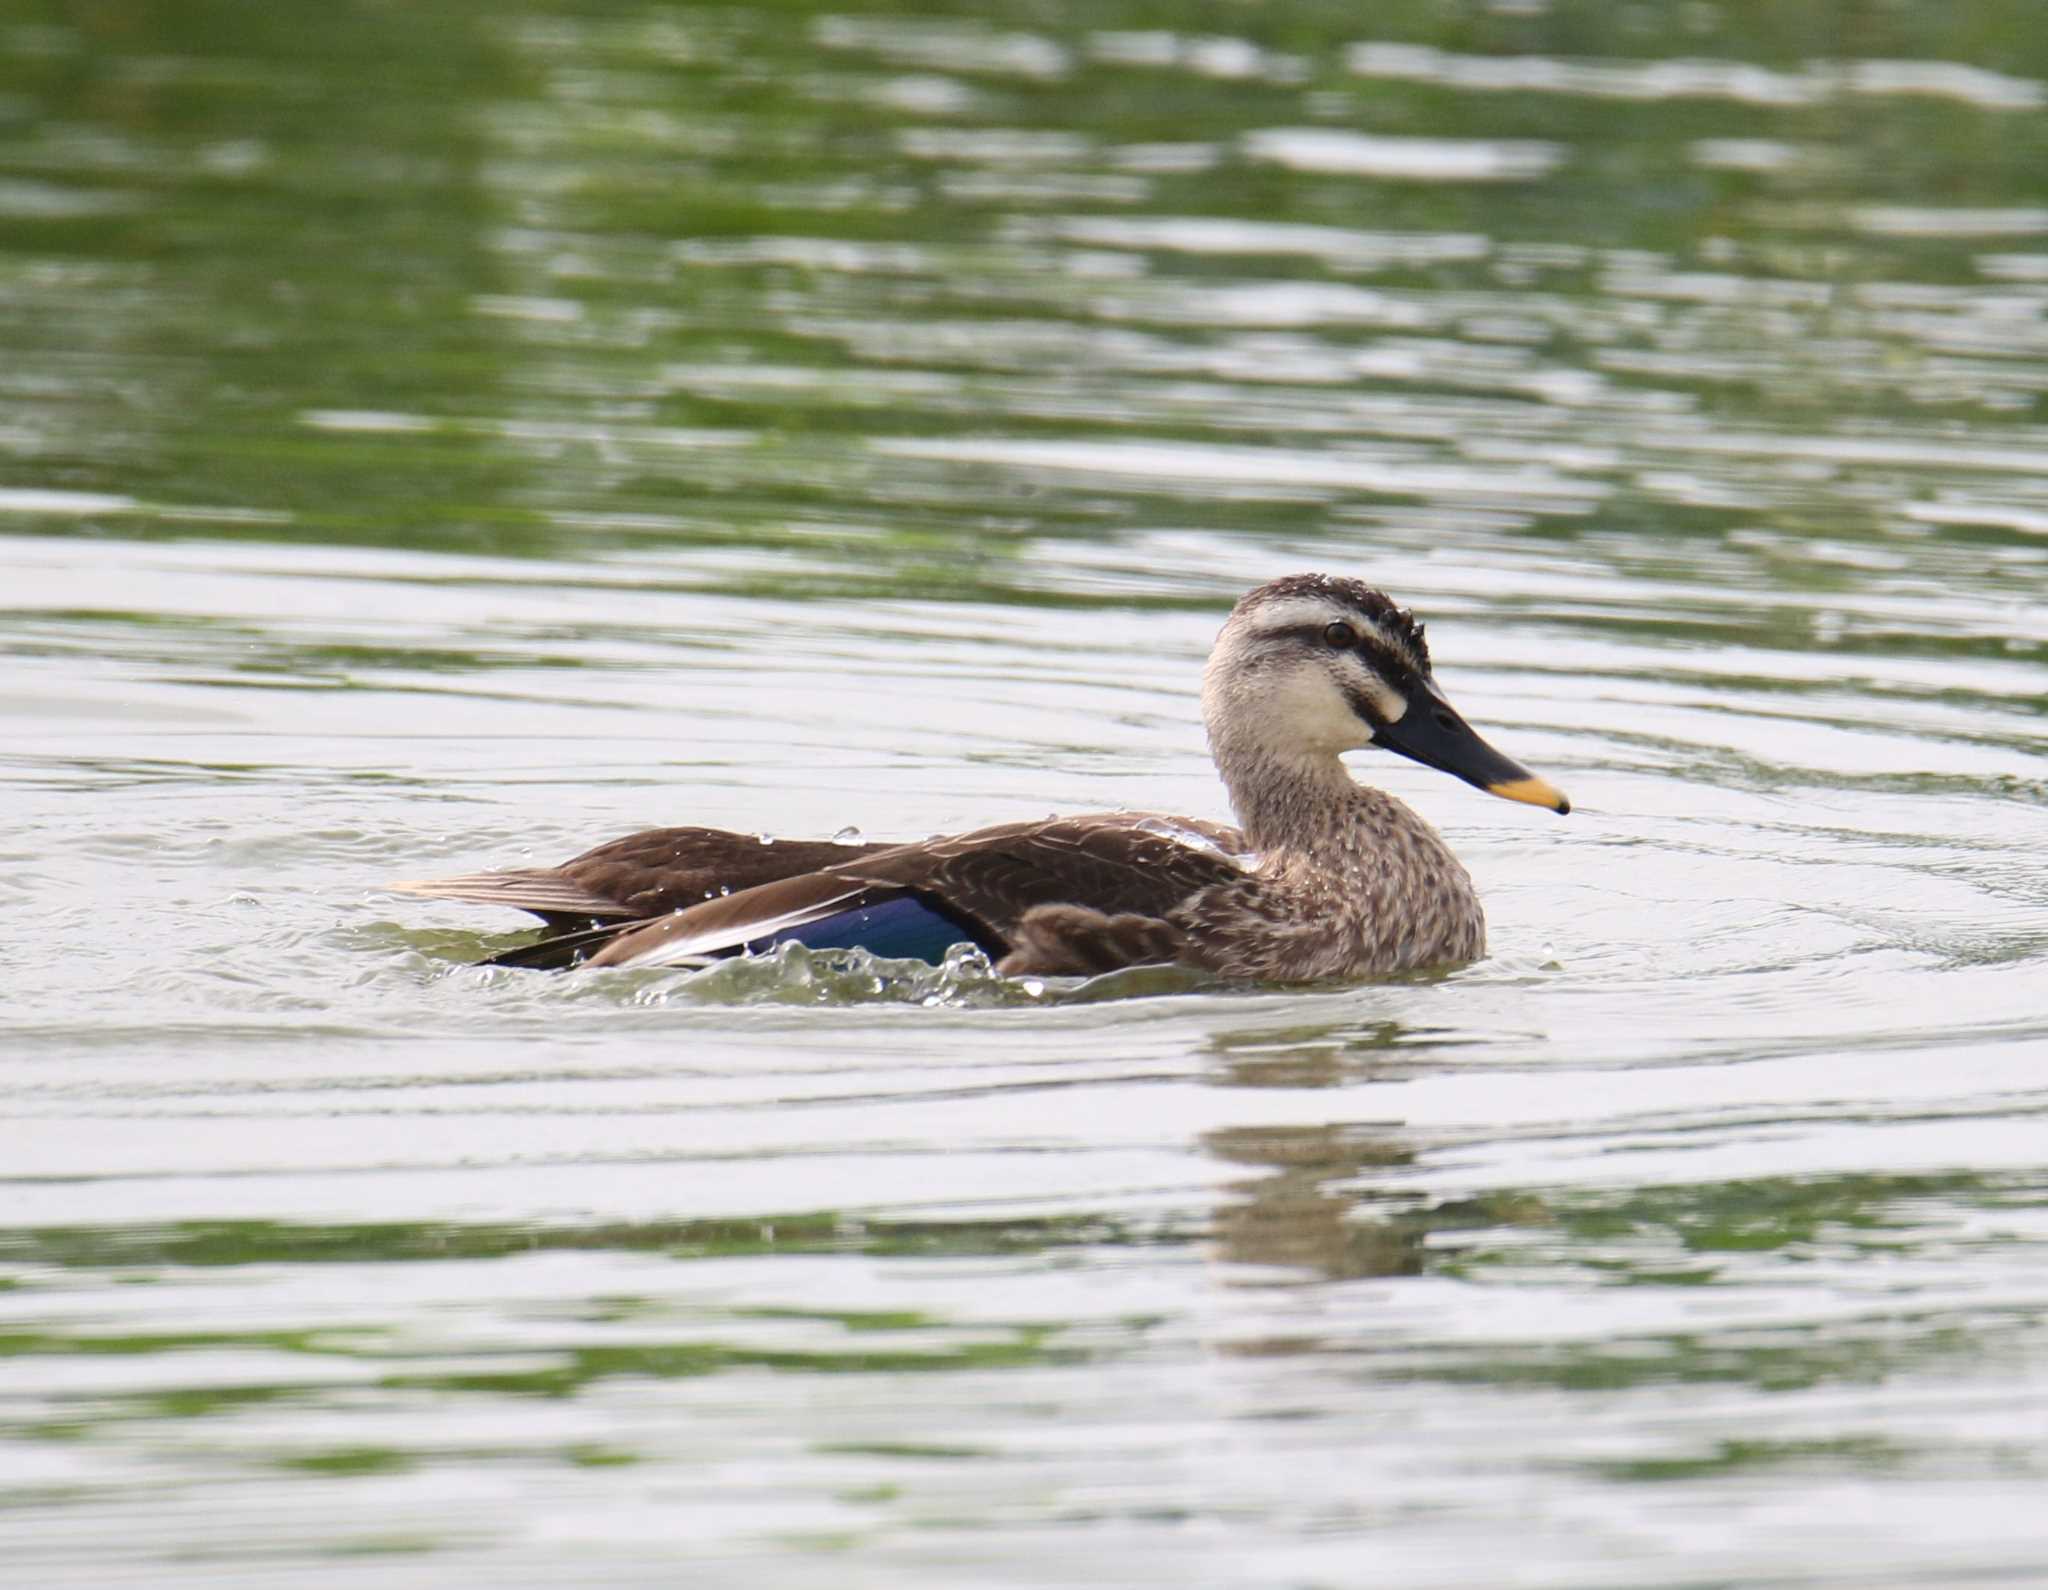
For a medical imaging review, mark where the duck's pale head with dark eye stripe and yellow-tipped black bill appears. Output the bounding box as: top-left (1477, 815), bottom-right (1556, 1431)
top-left (1202, 574), bottom-right (1571, 813)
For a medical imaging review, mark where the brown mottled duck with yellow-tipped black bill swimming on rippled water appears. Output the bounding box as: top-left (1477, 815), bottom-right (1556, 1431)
top-left (389, 574), bottom-right (1571, 984)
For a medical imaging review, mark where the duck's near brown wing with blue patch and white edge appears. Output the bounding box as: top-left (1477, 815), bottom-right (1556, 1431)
top-left (573, 813), bottom-right (1243, 971)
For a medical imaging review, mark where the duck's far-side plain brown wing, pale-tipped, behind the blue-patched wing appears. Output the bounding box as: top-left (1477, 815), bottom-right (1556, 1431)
top-left (387, 828), bottom-right (891, 928)
